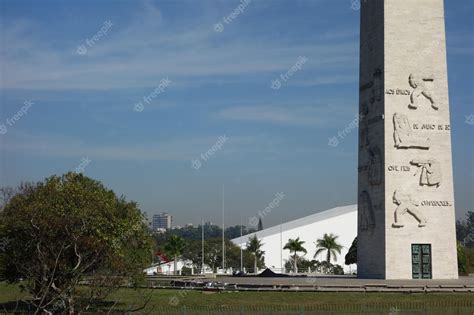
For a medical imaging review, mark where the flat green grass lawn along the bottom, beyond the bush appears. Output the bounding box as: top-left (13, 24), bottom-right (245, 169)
top-left (0, 283), bottom-right (474, 310)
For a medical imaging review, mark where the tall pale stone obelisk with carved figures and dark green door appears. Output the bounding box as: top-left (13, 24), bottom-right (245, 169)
top-left (358, 0), bottom-right (458, 279)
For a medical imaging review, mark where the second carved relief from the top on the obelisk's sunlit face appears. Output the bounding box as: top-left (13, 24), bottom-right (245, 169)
top-left (393, 113), bottom-right (430, 150)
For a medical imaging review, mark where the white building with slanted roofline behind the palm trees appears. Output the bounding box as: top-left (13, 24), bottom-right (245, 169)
top-left (232, 205), bottom-right (357, 273)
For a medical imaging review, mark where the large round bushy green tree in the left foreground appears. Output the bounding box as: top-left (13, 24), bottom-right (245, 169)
top-left (0, 173), bottom-right (152, 314)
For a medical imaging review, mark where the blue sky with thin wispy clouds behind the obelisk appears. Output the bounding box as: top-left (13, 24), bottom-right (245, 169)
top-left (0, 0), bottom-right (474, 226)
